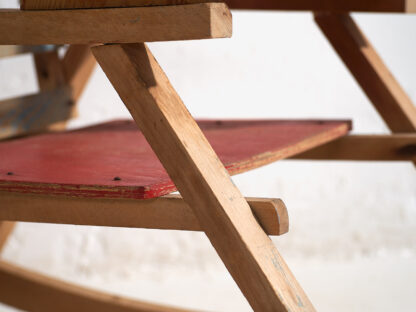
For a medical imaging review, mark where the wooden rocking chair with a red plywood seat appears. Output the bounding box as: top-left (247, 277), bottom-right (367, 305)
top-left (0, 0), bottom-right (415, 311)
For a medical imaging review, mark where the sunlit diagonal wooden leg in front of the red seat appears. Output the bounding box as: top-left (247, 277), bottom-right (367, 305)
top-left (93, 44), bottom-right (314, 312)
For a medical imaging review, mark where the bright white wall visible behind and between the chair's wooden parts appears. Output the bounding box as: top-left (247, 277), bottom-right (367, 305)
top-left (0, 0), bottom-right (416, 312)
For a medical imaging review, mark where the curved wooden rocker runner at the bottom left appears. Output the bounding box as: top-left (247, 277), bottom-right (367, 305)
top-left (0, 261), bottom-right (195, 312)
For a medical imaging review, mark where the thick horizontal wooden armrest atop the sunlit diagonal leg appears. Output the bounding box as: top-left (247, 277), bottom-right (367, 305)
top-left (0, 3), bottom-right (232, 45)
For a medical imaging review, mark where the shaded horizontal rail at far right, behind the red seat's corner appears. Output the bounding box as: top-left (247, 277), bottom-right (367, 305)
top-left (293, 134), bottom-right (416, 162)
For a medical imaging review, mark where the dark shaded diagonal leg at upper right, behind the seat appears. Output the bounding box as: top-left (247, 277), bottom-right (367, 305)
top-left (315, 13), bottom-right (416, 133)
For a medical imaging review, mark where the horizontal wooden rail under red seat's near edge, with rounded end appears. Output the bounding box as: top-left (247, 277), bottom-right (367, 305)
top-left (0, 192), bottom-right (289, 237)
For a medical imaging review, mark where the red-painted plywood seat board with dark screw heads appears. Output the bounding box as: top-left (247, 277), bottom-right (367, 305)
top-left (0, 120), bottom-right (351, 199)
